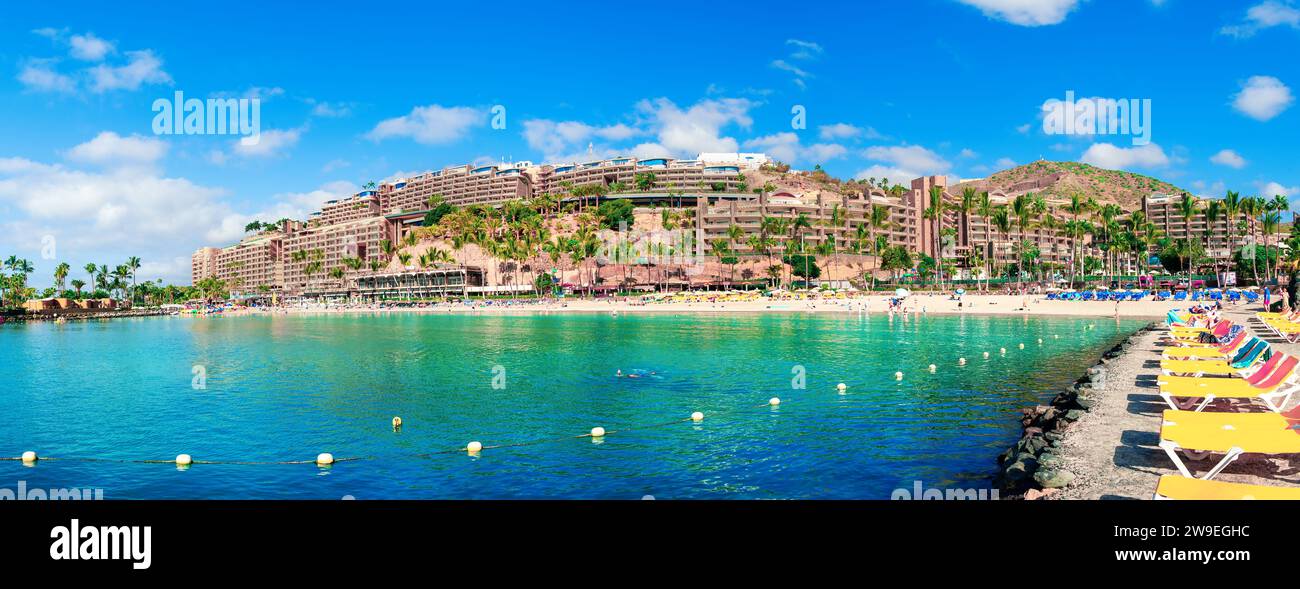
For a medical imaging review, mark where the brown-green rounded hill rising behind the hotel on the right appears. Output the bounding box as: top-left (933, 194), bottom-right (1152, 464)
top-left (949, 160), bottom-right (1188, 211)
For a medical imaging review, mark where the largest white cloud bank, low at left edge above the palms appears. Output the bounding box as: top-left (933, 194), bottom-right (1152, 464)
top-left (0, 141), bottom-right (358, 283)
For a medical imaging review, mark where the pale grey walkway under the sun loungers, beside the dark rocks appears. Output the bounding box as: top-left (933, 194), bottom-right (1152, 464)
top-left (1052, 309), bottom-right (1300, 499)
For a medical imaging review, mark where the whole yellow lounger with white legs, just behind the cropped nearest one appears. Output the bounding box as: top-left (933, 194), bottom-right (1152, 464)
top-left (1160, 410), bottom-right (1300, 480)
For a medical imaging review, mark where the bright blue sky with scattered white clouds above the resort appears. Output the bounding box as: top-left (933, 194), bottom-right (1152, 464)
top-left (0, 0), bottom-right (1300, 285)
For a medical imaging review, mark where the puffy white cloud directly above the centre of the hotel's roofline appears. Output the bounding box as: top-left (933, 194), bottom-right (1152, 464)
top-left (637, 98), bottom-right (754, 157)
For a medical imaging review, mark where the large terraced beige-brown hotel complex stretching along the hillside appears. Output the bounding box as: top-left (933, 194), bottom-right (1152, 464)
top-left (191, 153), bottom-right (1240, 296)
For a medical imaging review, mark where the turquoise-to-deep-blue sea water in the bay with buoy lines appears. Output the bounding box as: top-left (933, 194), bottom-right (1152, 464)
top-left (0, 313), bottom-right (1141, 499)
